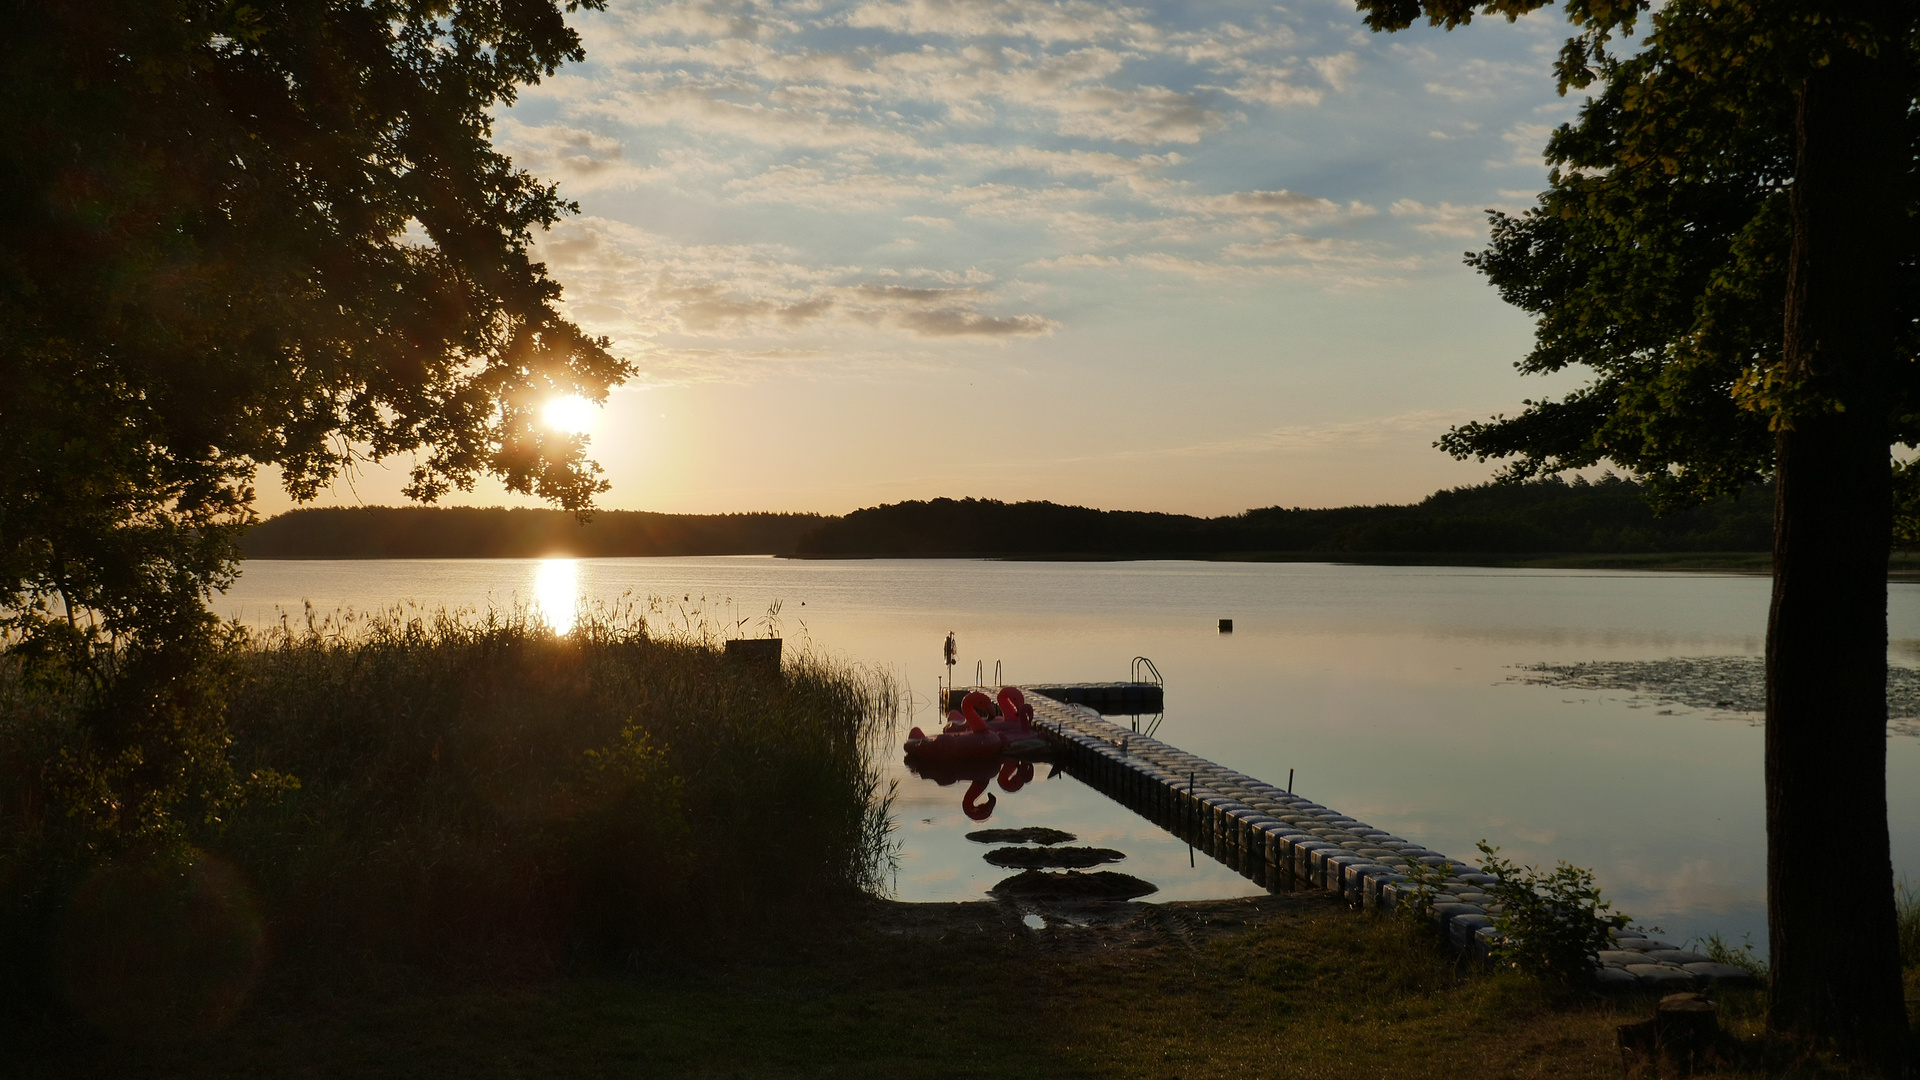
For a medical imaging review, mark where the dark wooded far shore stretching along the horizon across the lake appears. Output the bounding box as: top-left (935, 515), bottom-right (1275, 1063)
top-left (244, 477), bottom-right (1772, 559)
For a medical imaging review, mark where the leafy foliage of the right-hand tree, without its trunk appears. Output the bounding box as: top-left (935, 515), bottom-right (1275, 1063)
top-left (1361, 0), bottom-right (1920, 503)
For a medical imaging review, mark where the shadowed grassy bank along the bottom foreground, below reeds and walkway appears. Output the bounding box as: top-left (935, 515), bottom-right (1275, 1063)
top-left (23, 897), bottom-right (1651, 1080)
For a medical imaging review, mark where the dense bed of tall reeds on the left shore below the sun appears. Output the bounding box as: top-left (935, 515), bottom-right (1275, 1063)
top-left (0, 601), bottom-right (897, 1014)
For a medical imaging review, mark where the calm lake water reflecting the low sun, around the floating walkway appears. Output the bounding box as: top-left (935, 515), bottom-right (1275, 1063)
top-left (217, 557), bottom-right (1920, 949)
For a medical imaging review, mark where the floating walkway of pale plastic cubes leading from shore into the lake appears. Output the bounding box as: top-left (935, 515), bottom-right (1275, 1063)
top-left (1021, 684), bottom-right (1753, 990)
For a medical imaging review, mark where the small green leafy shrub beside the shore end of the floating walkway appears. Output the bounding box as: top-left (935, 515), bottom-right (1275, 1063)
top-left (1478, 840), bottom-right (1628, 984)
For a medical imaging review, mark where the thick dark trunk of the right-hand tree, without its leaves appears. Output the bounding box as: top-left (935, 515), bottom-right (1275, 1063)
top-left (1766, 2), bottom-right (1908, 1076)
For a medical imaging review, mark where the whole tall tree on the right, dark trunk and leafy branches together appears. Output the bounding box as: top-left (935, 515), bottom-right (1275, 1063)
top-left (1359, 0), bottom-right (1920, 1074)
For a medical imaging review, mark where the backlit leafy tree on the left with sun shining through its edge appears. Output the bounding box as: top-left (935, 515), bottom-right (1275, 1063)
top-left (0, 0), bottom-right (628, 834)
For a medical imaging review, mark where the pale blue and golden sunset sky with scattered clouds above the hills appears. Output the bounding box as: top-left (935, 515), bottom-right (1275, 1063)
top-left (261, 0), bottom-right (1578, 515)
